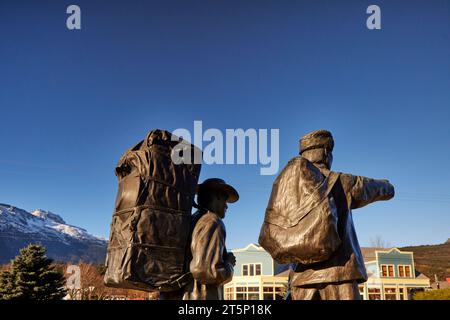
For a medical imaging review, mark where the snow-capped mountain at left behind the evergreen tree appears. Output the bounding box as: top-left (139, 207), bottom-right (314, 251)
top-left (0, 204), bottom-right (107, 263)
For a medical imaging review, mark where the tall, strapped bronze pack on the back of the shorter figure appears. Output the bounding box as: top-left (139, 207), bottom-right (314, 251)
top-left (104, 129), bottom-right (201, 292)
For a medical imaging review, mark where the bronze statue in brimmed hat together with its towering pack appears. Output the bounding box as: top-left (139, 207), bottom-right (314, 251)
top-left (104, 129), bottom-right (239, 300)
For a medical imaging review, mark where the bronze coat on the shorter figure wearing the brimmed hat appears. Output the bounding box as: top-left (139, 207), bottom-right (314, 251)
top-left (183, 211), bottom-right (233, 300)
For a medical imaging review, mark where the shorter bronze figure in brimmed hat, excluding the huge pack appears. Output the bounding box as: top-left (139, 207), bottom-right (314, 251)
top-left (183, 178), bottom-right (239, 300)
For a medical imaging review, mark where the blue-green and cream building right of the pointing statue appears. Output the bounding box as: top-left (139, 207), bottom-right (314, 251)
top-left (359, 248), bottom-right (430, 300)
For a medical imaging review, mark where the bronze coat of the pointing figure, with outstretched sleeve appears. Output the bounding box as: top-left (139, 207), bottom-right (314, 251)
top-left (290, 165), bottom-right (394, 286)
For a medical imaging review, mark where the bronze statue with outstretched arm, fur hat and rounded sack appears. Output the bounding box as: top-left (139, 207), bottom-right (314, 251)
top-left (259, 130), bottom-right (394, 300)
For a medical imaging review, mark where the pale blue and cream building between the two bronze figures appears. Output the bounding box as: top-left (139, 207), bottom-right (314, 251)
top-left (224, 243), bottom-right (288, 300)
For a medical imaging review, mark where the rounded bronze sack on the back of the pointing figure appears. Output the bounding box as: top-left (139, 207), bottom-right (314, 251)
top-left (259, 156), bottom-right (341, 264)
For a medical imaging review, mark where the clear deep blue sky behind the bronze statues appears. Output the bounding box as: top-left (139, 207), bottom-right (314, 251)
top-left (0, 0), bottom-right (450, 248)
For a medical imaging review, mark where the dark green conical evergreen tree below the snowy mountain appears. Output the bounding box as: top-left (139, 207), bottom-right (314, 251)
top-left (0, 244), bottom-right (66, 300)
